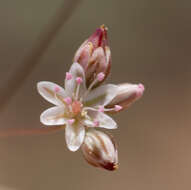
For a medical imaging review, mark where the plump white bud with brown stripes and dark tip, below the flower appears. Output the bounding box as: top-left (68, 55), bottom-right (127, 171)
top-left (82, 129), bottom-right (118, 171)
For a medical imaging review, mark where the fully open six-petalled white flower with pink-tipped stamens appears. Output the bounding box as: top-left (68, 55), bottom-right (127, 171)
top-left (37, 63), bottom-right (121, 151)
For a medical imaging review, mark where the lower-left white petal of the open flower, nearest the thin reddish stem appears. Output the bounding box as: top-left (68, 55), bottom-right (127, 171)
top-left (40, 106), bottom-right (66, 125)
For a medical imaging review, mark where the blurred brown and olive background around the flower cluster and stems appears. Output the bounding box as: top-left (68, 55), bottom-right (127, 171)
top-left (0, 0), bottom-right (191, 190)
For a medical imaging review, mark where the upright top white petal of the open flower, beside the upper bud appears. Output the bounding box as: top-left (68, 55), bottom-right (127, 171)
top-left (65, 63), bottom-right (86, 97)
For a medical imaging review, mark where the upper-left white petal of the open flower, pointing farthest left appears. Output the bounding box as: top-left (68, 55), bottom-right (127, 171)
top-left (37, 81), bottom-right (66, 105)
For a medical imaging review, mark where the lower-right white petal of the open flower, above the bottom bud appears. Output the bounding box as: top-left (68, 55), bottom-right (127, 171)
top-left (84, 110), bottom-right (117, 129)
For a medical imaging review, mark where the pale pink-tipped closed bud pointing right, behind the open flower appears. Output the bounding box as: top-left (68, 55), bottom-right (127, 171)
top-left (106, 83), bottom-right (144, 113)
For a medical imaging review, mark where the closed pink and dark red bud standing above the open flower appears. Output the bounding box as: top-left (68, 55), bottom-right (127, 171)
top-left (74, 25), bottom-right (111, 86)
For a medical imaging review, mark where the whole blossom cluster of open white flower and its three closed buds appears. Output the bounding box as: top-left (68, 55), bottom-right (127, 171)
top-left (37, 25), bottom-right (144, 170)
